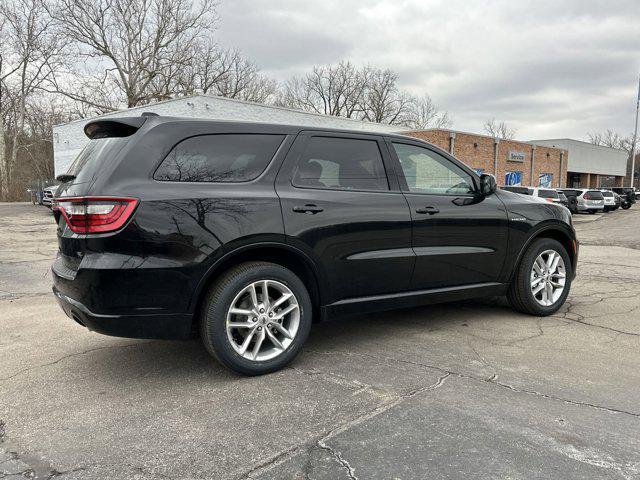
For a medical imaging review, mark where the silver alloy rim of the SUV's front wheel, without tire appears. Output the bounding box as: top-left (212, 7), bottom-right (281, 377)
top-left (531, 250), bottom-right (567, 307)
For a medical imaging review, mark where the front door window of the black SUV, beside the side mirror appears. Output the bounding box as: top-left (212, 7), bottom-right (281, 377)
top-left (393, 143), bottom-right (474, 195)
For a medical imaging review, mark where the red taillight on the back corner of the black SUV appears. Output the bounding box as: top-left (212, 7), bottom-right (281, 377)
top-left (53, 197), bottom-right (138, 234)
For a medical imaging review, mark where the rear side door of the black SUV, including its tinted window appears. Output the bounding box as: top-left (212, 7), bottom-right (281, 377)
top-left (276, 132), bottom-right (414, 302)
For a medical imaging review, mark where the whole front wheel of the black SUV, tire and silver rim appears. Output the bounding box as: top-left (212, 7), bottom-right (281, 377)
top-left (507, 238), bottom-right (572, 316)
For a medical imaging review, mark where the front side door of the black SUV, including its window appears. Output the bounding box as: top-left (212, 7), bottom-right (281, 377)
top-left (389, 140), bottom-right (507, 290)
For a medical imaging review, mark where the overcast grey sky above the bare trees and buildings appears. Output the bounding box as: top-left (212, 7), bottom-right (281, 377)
top-left (218, 0), bottom-right (640, 140)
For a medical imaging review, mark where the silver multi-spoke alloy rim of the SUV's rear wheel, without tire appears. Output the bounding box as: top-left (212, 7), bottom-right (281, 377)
top-left (226, 280), bottom-right (300, 361)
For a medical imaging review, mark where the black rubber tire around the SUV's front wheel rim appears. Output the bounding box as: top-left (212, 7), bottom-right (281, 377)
top-left (507, 238), bottom-right (573, 316)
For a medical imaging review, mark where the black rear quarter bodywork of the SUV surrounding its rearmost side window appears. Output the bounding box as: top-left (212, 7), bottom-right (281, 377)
top-left (59, 122), bottom-right (293, 314)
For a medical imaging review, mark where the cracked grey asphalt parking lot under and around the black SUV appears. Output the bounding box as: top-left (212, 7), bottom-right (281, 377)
top-left (0, 204), bottom-right (640, 480)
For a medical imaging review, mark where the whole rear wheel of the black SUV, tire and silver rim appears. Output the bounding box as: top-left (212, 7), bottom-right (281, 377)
top-left (200, 262), bottom-right (312, 375)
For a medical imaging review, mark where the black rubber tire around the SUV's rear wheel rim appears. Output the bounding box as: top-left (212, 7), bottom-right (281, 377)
top-left (200, 262), bottom-right (312, 375)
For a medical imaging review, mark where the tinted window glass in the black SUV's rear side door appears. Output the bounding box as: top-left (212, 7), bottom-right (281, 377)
top-left (293, 137), bottom-right (389, 191)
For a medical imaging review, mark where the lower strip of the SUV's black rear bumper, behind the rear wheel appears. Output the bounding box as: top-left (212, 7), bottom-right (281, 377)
top-left (53, 286), bottom-right (193, 340)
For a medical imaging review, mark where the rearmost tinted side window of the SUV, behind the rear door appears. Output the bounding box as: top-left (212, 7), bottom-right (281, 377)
top-left (153, 134), bottom-right (284, 182)
